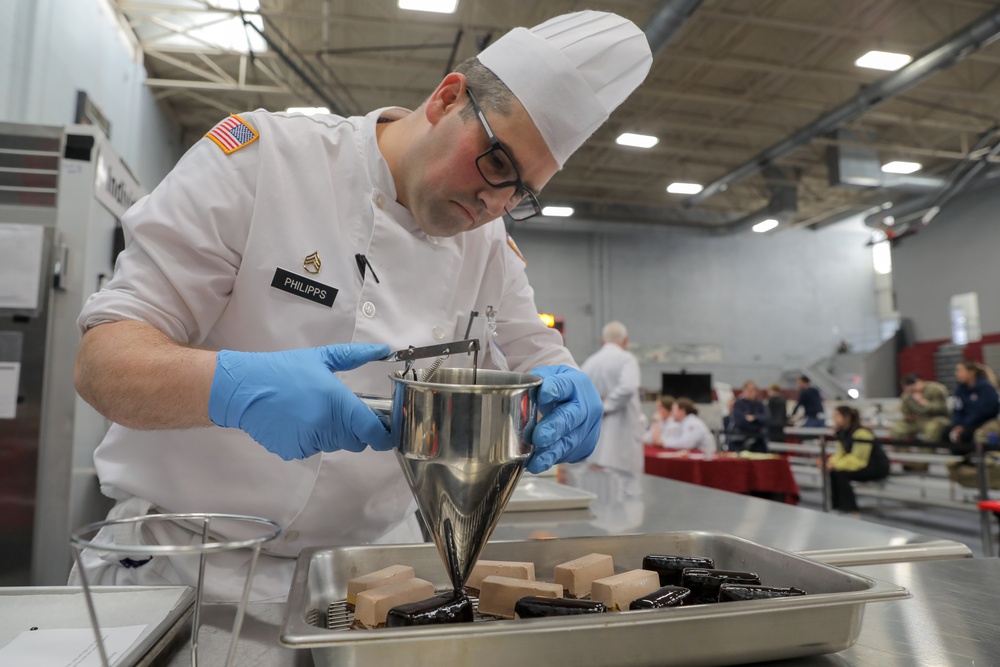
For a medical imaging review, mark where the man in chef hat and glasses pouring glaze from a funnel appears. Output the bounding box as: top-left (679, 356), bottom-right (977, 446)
top-left (71, 11), bottom-right (652, 600)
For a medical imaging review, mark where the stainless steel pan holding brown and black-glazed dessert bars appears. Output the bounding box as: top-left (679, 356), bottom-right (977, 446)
top-left (281, 532), bottom-right (909, 667)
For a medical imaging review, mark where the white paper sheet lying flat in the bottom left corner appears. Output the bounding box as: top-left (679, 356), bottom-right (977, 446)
top-left (0, 625), bottom-right (146, 667)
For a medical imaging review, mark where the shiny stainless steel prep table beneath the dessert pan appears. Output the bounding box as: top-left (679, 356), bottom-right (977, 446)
top-left (148, 467), bottom-right (984, 667)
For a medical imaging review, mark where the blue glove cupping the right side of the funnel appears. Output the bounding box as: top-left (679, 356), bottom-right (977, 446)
top-left (528, 366), bottom-right (604, 474)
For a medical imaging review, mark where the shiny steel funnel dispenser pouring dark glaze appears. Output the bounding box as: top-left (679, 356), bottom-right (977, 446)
top-left (390, 368), bottom-right (542, 590)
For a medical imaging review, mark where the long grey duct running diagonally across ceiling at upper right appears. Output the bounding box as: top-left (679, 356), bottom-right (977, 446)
top-left (684, 9), bottom-right (1000, 207)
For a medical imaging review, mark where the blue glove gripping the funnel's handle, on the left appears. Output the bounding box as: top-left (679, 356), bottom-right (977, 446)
top-left (208, 343), bottom-right (392, 461)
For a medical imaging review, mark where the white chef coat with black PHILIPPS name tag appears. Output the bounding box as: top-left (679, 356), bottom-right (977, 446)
top-left (79, 108), bottom-right (573, 599)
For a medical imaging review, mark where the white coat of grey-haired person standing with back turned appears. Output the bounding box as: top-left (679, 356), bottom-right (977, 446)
top-left (580, 343), bottom-right (644, 473)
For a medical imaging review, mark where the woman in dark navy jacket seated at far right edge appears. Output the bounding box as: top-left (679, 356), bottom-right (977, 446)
top-left (949, 359), bottom-right (1000, 454)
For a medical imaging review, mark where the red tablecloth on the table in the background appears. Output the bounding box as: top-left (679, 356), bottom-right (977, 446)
top-left (646, 447), bottom-right (799, 505)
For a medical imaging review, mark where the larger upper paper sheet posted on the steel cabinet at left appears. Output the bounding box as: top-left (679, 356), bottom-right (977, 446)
top-left (0, 224), bottom-right (45, 310)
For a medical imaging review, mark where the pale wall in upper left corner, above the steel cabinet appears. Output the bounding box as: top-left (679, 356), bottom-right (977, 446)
top-left (0, 0), bottom-right (182, 189)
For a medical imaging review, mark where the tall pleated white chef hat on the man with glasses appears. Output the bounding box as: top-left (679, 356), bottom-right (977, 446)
top-left (479, 11), bottom-right (653, 167)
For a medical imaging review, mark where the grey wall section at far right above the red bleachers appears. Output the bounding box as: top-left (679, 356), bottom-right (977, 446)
top-left (892, 181), bottom-right (1000, 341)
